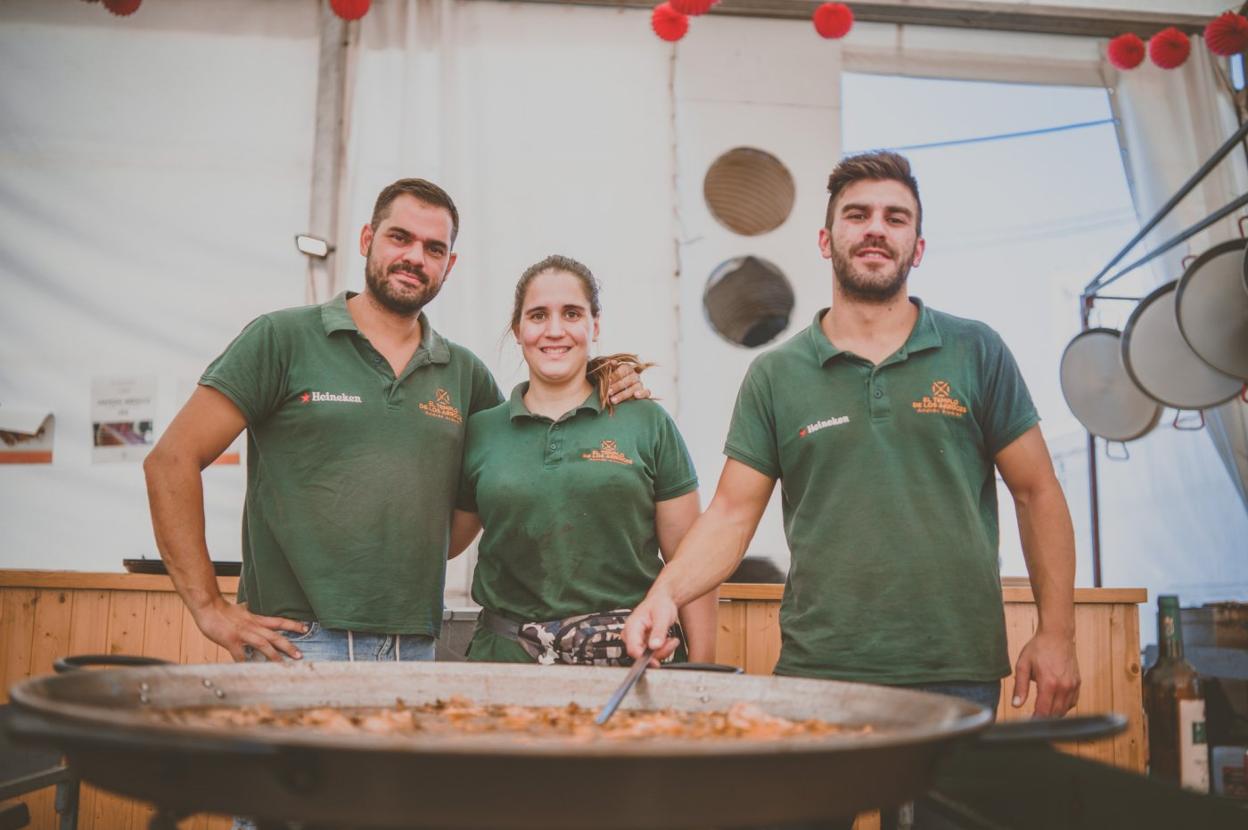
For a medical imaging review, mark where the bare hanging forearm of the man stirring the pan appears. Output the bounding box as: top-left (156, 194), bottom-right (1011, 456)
top-left (1015, 481), bottom-right (1075, 638)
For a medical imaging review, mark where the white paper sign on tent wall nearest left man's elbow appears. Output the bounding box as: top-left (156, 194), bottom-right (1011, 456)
top-left (91, 376), bottom-right (156, 464)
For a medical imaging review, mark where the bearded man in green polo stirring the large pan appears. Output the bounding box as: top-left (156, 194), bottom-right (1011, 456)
top-left (624, 152), bottom-right (1080, 813)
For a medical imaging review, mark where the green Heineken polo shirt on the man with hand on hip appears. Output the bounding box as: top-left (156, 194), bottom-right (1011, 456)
top-left (200, 293), bottom-right (502, 635)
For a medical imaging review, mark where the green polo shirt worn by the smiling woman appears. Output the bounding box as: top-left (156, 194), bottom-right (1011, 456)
top-left (458, 383), bottom-right (698, 662)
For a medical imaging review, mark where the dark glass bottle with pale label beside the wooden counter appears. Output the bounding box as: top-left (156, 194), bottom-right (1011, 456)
top-left (1144, 595), bottom-right (1209, 793)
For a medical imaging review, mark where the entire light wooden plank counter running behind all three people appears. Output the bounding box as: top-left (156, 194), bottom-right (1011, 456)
top-left (0, 570), bottom-right (1147, 830)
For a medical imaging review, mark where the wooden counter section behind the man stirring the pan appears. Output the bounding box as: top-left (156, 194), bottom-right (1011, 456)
top-left (715, 578), bottom-right (1148, 773)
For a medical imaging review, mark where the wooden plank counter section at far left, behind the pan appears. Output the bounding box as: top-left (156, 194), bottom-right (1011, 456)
top-left (0, 588), bottom-right (231, 830)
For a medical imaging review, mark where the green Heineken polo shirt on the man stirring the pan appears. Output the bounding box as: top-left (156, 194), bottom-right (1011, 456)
top-left (724, 298), bottom-right (1038, 684)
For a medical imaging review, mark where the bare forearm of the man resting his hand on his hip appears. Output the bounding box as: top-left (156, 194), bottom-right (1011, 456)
top-left (144, 451), bottom-right (223, 617)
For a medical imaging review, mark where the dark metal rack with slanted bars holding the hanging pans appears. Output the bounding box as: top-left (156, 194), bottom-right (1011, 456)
top-left (1080, 121), bottom-right (1248, 588)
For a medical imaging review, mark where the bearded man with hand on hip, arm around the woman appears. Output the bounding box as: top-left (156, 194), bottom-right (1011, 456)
top-left (144, 178), bottom-right (645, 660)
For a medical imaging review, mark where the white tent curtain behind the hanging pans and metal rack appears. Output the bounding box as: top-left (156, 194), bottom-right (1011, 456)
top-left (1101, 39), bottom-right (1248, 604)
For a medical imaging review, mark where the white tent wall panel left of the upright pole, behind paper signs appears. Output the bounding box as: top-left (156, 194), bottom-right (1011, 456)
top-left (0, 0), bottom-right (317, 570)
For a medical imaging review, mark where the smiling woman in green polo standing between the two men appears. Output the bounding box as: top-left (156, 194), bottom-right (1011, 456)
top-left (452, 256), bottom-right (716, 663)
